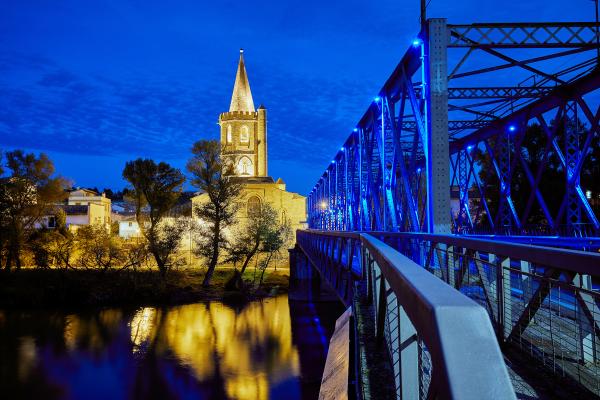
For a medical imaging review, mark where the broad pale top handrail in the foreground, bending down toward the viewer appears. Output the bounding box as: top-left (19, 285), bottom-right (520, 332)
top-left (360, 234), bottom-right (515, 399)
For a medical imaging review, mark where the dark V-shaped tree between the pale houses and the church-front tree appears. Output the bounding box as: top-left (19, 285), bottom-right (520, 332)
top-left (123, 158), bottom-right (185, 277)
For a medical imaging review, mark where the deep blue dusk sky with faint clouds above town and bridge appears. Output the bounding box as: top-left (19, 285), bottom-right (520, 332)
top-left (0, 0), bottom-right (594, 193)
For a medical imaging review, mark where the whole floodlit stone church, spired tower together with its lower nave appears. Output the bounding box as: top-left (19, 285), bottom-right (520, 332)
top-left (192, 50), bottom-right (306, 238)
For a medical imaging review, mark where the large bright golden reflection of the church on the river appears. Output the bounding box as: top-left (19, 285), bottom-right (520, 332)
top-left (129, 296), bottom-right (299, 400)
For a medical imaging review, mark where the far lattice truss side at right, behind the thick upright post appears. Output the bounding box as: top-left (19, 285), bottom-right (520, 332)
top-left (450, 70), bottom-right (600, 236)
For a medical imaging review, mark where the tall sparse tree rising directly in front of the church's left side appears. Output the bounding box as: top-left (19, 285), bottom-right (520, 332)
top-left (187, 140), bottom-right (241, 286)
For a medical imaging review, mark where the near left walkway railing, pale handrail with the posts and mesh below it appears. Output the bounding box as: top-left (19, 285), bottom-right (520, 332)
top-left (296, 230), bottom-right (515, 399)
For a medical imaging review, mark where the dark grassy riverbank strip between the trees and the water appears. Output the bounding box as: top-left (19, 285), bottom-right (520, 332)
top-left (0, 269), bottom-right (289, 308)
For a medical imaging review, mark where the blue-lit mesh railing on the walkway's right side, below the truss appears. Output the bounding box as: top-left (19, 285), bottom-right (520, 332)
top-left (364, 232), bottom-right (600, 395)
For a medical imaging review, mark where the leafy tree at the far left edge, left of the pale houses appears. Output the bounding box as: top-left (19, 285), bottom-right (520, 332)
top-left (0, 150), bottom-right (68, 270)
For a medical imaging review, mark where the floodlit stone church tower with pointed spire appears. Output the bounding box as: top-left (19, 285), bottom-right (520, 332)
top-left (219, 49), bottom-right (268, 177)
